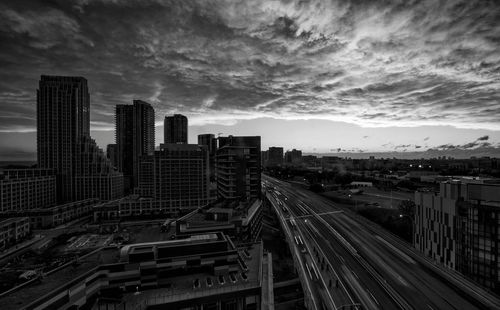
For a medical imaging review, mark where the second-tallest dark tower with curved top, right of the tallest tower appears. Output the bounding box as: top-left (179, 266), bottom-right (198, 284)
top-left (115, 100), bottom-right (155, 192)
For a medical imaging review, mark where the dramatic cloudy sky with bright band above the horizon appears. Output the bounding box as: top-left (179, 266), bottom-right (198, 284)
top-left (0, 0), bottom-right (500, 160)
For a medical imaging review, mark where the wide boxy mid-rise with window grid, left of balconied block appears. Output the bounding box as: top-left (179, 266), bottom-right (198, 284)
top-left (136, 144), bottom-right (209, 209)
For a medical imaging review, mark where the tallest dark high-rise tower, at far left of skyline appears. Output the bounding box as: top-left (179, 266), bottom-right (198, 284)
top-left (37, 75), bottom-right (90, 201)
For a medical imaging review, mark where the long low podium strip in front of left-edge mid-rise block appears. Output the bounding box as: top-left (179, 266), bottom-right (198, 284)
top-left (0, 198), bottom-right (99, 229)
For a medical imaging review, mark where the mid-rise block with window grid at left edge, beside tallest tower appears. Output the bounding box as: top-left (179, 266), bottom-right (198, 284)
top-left (0, 169), bottom-right (56, 212)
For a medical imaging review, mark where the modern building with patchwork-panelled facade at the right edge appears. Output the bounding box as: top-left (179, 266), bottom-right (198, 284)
top-left (414, 177), bottom-right (500, 294)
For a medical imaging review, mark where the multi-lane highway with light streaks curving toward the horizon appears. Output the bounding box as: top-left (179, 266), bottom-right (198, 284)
top-left (263, 176), bottom-right (500, 310)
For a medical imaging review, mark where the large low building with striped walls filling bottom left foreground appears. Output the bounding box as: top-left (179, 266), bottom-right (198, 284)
top-left (0, 233), bottom-right (273, 310)
